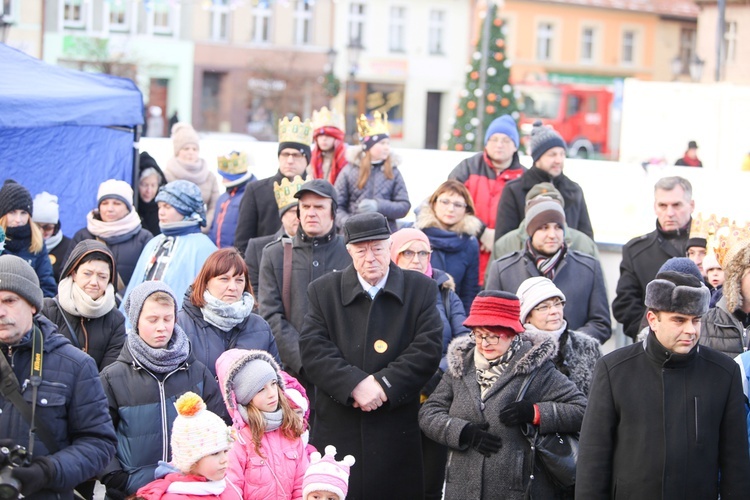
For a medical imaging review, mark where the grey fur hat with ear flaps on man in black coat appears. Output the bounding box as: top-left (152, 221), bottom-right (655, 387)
top-left (646, 271), bottom-right (711, 316)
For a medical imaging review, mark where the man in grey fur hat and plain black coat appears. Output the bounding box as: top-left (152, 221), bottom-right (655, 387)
top-left (576, 271), bottom-right (750, 500)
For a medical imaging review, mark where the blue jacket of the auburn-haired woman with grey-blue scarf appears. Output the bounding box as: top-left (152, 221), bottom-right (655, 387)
top-left (177, 287), bottom-right (280, 377)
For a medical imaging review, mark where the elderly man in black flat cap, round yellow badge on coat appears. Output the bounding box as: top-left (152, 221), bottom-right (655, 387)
top-left (300, 212), bottom-right (442, 500)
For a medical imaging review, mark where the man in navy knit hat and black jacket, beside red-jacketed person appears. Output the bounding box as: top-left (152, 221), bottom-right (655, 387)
top-left (495, 121), bottom-right (594, 241)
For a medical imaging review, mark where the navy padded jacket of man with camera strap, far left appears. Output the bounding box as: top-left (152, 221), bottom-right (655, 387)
top-left (0, 314), bottom-right (116, 500)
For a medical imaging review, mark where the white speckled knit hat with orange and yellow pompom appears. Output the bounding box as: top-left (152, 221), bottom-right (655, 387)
top-left (172, 392), bottom-right (233, 474)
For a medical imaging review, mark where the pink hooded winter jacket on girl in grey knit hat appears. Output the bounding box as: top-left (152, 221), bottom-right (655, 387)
top-left (216, 349), bottom-right (309, 500)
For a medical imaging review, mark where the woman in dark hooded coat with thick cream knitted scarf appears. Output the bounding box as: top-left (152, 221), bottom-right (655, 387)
top-left (42, 240), bottom-right (125, 371)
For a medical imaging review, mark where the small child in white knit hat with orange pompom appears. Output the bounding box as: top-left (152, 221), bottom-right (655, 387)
top-left (135, 392), bottom-right (242, 500)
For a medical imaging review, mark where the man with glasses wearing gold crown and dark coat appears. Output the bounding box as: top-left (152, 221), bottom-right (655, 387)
top-left (234, 116), bottom-right (313, 255)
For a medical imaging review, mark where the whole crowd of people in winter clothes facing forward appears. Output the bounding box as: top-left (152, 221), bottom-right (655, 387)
top-left (0, 108), bottom-right (750, 500)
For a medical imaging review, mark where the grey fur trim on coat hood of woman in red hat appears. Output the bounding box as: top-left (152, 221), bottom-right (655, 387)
top-left (446, 335), bottom-right (557, 378)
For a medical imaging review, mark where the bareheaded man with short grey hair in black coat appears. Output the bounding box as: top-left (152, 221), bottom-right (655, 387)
top-left (612, 176), bottom-right (695, 340)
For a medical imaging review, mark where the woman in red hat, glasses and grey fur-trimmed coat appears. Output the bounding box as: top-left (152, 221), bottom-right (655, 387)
top-left (419, 291), bottom-right (586, 500)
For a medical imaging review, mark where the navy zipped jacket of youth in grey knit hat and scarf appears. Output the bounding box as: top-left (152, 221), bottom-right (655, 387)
top-left (101, 332), bottom-right (228, 495)
